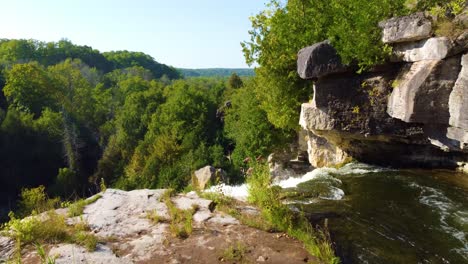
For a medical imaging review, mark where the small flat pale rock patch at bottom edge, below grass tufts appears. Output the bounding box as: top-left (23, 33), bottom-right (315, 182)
top-left (49, 244), bottom-right (133, 264)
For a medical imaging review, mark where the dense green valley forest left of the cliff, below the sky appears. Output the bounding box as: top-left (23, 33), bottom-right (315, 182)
top-left (0, 39), bottom-right (282, 217)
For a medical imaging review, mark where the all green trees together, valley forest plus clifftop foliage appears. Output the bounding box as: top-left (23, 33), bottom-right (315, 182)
top-left (0, 0), bottom-right (461, 217)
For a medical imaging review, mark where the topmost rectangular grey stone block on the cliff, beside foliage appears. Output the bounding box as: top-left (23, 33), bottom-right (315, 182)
top-left (379, 12), bottom-right (432, 43)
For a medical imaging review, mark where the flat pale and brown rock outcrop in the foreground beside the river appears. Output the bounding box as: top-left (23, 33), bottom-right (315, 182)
top-left (0, 189), bottom-right (318, 264)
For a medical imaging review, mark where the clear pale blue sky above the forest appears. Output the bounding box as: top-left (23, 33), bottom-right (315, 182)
top-left (0, 0), bottom-right (267, 68)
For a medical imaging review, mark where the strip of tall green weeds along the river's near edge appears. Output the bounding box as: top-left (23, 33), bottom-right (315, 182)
top-left (247, 164), bottom-right (339, 263)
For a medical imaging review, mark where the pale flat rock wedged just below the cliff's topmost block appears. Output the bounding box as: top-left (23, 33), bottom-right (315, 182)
top-left (391, 37), bottom-right (453, 62)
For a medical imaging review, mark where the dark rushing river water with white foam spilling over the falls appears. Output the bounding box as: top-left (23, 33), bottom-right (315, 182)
top-left (211, 163), bottom-right (468, 264)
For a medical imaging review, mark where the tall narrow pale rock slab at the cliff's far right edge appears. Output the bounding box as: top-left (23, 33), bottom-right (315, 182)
top-left (449, 54), bottom-right (468, 130)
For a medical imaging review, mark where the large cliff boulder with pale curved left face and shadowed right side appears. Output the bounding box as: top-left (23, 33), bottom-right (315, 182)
top-left (387, 57), bottom-right (460, 125)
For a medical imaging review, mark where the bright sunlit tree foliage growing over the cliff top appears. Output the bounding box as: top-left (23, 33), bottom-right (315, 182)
top-left (242, 0), bottom-right (406, 129)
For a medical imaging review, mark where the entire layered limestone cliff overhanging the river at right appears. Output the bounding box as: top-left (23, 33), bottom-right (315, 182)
top-left (298, 13), bottom-right (468, 171)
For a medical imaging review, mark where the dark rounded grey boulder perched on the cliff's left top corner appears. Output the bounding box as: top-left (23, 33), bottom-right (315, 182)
top-left (297, 40), bottom-right (348, 79)
